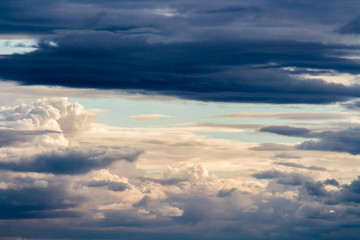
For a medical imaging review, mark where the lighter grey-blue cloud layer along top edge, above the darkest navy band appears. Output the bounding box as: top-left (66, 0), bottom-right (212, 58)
top-left (0, 0), bottom-right (360, 36)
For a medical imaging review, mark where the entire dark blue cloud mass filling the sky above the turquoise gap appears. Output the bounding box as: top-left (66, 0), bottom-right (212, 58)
top-left (0, 0), bottom-right (360, 103)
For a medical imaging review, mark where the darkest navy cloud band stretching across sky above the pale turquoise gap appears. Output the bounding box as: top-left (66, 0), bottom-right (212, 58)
top-left (0, 37), bottom-right (360, 103)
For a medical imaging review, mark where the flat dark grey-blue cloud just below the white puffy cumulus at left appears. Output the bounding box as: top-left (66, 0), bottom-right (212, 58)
top-left (0, 147), bottom-right (141, 175)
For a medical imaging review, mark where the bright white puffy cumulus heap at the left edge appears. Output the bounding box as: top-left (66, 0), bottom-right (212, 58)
top-left (0, 98), bottom-right (96, 150)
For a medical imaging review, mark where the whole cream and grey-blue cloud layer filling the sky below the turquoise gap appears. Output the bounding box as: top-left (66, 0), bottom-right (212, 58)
top-left (0, 99), bottom-right (360, 239)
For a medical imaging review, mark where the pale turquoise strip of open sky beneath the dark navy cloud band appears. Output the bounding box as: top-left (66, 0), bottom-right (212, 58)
top-left (69, 96), bottom-right (348, 143)
